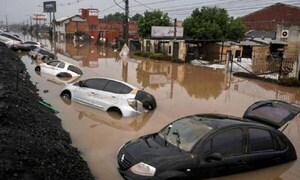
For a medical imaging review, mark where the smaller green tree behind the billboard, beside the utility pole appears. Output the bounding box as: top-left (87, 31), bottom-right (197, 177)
top-left (138, 10), bottom-right (171, 38)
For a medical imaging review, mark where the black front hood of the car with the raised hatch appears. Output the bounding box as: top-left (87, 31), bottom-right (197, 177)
top-left (119, 133), bottom-right (196, 170)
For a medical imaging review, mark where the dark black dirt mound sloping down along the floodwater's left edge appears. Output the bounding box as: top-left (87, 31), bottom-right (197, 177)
top-left (0, 44), bottom-right (94, 180)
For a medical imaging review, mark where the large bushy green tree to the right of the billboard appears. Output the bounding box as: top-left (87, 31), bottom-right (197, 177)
top-left (183, 7), bottom-right (246, 40)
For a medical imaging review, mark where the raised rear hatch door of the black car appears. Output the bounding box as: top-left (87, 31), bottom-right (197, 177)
top-left (243, 100), bottom-right (300, 129)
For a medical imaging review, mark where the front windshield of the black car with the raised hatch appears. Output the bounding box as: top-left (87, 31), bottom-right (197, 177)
top-left (159, 116), bottom-right (213, 151)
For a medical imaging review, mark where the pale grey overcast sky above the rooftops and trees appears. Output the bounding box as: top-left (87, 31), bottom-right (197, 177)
top-left (0, 0), bottom-right (300, 25)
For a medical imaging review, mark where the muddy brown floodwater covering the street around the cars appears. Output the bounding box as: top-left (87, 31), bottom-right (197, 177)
top-left (22, 45), bottom-right (300, 180)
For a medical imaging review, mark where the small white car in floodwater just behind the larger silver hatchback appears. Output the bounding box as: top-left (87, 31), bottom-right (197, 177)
top-left (35, 60), bottom-right (83, 77)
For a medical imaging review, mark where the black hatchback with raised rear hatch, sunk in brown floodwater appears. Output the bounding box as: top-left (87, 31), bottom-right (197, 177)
top-left (117, 100), bottom-right (300, 180)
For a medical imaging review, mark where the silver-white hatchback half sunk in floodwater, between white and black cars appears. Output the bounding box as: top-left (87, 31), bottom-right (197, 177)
top-left (61, 77), bottom-right (156, 117)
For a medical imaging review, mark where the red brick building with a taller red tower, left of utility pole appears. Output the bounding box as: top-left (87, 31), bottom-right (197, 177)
top-left (56, 8), bottom-right (139, 44)
